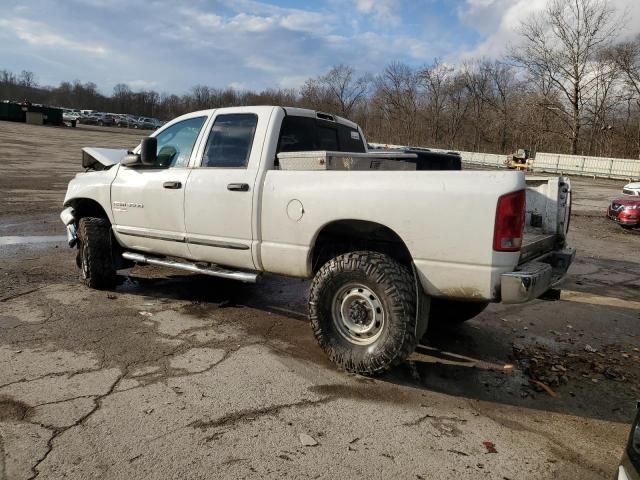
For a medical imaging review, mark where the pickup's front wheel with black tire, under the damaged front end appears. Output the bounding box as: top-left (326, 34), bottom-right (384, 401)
top-left (78, 217), bottom-right (116, 289)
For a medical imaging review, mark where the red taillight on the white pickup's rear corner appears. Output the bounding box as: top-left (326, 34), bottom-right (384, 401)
top-left (493, 190), bottom-right (526, 252)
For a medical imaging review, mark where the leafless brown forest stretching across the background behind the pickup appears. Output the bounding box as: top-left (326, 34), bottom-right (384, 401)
top-left (0, 0), bottom-right (640, 159)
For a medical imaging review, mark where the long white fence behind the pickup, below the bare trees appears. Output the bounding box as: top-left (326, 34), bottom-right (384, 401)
top-left (364, 144), bottom-right (640, 180)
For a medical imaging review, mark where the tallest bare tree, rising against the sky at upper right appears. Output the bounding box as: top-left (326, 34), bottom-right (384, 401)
top-left (512, 0), bottom-right (614, 154)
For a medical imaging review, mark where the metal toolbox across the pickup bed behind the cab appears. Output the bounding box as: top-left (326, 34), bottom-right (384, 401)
top-left (278, 150), bottom-right (417, 170)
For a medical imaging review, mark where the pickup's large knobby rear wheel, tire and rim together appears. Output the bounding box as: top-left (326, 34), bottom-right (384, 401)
top-left (309, 251), bottom-right (417, 375)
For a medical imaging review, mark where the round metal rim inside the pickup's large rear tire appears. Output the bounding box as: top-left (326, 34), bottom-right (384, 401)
top-left (332, 283), bottom-right (385, 345)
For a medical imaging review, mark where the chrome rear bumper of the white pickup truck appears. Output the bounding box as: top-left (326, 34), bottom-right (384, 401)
top-left (500, 248), bottom-right (576, 303)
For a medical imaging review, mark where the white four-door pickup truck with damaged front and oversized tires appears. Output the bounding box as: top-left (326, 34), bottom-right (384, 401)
top-left (61, 106), bottom-right (574, 375)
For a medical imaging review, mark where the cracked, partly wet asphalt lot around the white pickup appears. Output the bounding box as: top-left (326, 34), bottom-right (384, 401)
top-left (0, 122), bottom-right (640, 480)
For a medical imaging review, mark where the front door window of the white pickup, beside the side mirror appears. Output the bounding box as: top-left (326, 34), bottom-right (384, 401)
top-left (156, 117), bottom-right (207, 167)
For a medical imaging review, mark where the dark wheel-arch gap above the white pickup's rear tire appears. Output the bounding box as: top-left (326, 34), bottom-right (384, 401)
top-left (308, 219), bottom-right (412, 274)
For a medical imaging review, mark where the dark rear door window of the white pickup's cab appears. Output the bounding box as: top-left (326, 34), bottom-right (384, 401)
top-left (202, 113), bottom-right (258, 168)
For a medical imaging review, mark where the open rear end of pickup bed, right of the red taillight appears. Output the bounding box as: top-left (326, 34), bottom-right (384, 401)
top-left (519, 177), bottom-right (571, 264)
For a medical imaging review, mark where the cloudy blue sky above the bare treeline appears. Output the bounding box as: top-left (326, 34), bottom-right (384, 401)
top-left (0, 0), bottom-right (640, 94)
